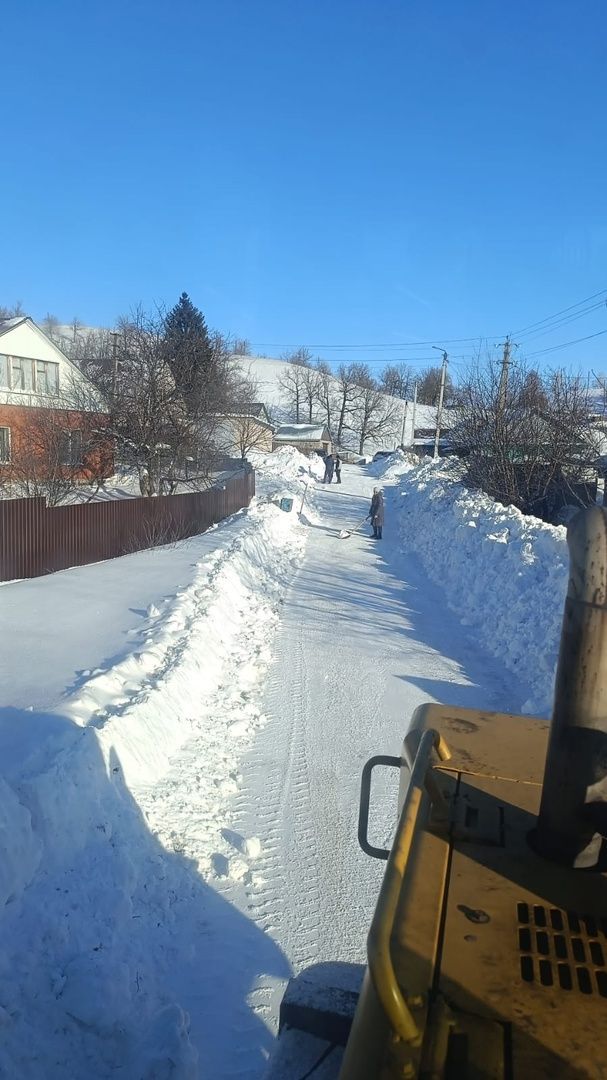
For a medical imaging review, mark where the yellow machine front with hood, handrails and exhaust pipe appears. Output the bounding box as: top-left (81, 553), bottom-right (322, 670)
top-left (270, 508), bottom-right (607, 1080)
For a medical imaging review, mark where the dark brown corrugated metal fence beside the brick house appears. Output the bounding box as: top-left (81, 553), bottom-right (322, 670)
top-left (0, 472), bottom-right (255, 581)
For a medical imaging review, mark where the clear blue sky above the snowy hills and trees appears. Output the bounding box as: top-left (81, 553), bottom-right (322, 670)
top-left (0, 0), bottom-right (607, 369)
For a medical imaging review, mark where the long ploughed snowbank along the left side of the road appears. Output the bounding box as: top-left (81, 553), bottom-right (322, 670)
top-left (0, 462), bottom-right (306, 1080)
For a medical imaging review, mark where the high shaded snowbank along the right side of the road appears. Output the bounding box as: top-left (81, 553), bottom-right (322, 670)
top-left (383, 460), bottom-right (568, 716)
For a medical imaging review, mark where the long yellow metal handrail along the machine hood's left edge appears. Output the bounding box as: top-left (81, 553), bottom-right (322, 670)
top-left (367, 729), bottom-right (449, 1045)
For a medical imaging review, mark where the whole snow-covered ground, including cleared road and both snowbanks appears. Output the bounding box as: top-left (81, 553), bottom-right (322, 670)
top-left (0, 450), bottom-right (565, 1080)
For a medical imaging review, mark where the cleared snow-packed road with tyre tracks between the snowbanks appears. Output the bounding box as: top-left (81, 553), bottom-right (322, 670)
top-left (211, 468), bottom-right (524, 1077)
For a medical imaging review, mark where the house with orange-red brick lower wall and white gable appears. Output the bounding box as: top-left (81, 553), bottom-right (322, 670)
top-left (0, 316), bottom-right (113, 494)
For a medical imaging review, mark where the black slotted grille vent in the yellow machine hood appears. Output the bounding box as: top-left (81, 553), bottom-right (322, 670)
top-left (516, 904), bottom-right (607, 998)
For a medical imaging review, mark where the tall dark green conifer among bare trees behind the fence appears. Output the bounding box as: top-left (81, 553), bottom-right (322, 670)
top-left (164, 293), bottom-right (213, 399)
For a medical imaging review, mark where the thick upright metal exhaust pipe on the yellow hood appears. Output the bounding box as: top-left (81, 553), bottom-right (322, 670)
top-left (530, 507), bottom-right (607, 869)
